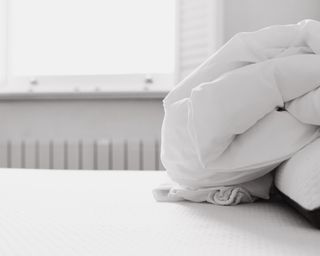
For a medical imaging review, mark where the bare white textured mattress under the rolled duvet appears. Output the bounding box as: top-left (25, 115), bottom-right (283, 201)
top-left (0, 170), bottom-right (320, 256)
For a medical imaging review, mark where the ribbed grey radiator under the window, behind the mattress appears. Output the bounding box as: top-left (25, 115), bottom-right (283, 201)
top-left (0, 139), bottom-right (163, 170)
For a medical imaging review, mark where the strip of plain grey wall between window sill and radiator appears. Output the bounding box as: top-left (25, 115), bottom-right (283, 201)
top-left (0, 99), bottom-right (163, 140)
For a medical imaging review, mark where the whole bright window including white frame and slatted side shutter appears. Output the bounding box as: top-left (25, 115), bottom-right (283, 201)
top-left (0, 0), bottom-right (223, 90)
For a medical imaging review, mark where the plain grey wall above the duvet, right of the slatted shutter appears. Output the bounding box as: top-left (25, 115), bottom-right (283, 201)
top-left (224, 0), bottom-right (320, 40)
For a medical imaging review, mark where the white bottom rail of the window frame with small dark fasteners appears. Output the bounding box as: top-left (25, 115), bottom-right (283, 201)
top-left (7, 74), bottom-right (174, 93)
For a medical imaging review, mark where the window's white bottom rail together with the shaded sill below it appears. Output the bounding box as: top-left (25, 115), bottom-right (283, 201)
top-left (0, 74), bottom-right (174, 100)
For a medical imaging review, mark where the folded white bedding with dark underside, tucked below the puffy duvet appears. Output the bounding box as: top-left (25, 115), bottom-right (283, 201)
top-left (274, 139), bottom-right (320, 228)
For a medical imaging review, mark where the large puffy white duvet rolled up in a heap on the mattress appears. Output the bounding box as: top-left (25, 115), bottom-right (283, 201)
top-left (154, 20), bottom-right (320, 205)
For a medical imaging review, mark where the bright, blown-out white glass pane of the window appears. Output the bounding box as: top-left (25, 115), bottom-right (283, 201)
top-left (9, 0), bottom-right (175, 76)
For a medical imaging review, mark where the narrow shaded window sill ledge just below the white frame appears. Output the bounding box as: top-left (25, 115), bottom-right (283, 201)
top-left (0, 88), bottom-right (169, 101)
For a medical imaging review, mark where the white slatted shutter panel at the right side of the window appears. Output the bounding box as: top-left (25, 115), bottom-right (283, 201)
top-left (177, 0), bottom-right (223, 81)
